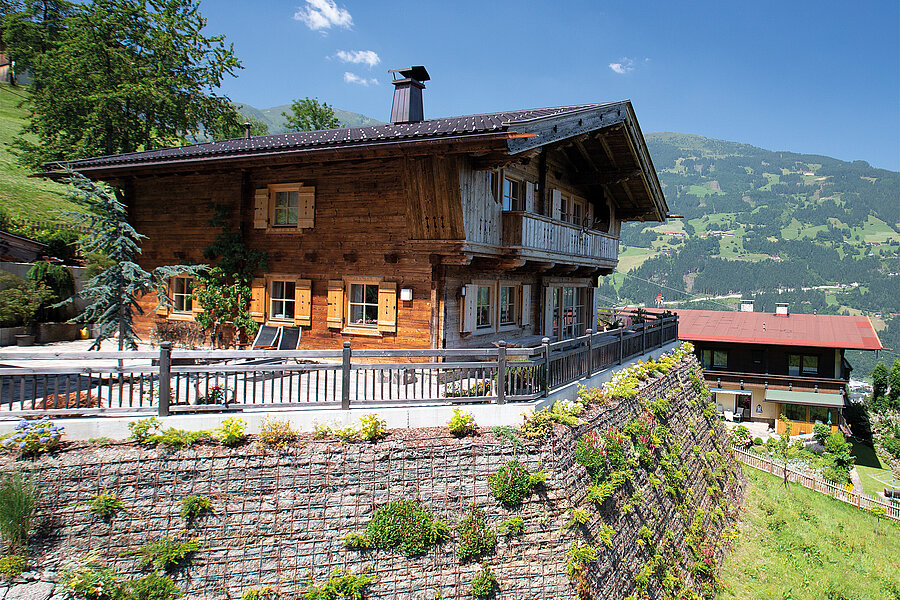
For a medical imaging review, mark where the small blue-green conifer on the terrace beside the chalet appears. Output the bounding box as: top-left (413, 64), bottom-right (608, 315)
top-left (68, 172), bottom-right (205, 350)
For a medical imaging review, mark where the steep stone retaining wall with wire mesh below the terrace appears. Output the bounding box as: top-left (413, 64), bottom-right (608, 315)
top-left (4, 357), bottom-right (743, 600)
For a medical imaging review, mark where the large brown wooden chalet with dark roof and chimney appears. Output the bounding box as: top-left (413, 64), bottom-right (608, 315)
top-left (56, 67), bottom-right (668, 348)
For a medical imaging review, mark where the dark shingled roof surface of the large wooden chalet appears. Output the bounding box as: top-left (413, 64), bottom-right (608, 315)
top-left (61, 104), bottom-right (606, 170)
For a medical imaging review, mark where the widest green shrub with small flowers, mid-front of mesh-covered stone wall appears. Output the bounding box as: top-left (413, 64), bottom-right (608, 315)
top-left (344, 500), bottom-right (450, 556)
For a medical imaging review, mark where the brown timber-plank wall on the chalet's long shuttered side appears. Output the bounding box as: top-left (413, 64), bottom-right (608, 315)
top-left (129, 159), bottom-right (434, 348)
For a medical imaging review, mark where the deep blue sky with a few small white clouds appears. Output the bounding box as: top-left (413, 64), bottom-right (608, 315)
top-left (201, 0), bottom-right (900, 170)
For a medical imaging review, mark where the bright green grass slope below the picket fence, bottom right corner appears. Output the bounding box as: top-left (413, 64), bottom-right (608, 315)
top-left (717, 467), bottom-right (900, 600)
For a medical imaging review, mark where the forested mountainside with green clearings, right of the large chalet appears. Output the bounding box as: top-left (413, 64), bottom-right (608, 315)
top-left (600, 133), bottom-right (900, 380)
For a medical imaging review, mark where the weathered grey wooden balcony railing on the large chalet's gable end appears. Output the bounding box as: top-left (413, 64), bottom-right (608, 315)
top-left (503, 211), bottom-right (619, 266)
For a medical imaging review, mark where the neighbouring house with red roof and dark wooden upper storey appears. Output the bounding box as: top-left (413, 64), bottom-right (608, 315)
top-left (652, 302), bottom-right (883, 435)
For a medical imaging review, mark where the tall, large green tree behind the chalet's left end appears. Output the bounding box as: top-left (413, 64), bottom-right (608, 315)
top-left (3, 0), bottom-right (241, 164)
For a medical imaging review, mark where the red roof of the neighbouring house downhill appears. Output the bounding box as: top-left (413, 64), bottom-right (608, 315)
top-left (653, 309), bottom-right (883, 350)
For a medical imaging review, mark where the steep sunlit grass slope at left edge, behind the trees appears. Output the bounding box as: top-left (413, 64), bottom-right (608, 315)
top-left (0, 83), bottom-right (78, 221)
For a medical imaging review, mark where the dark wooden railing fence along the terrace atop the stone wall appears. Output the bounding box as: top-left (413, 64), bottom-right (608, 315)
top-left (0, 317), bottom-right (678, 416)
